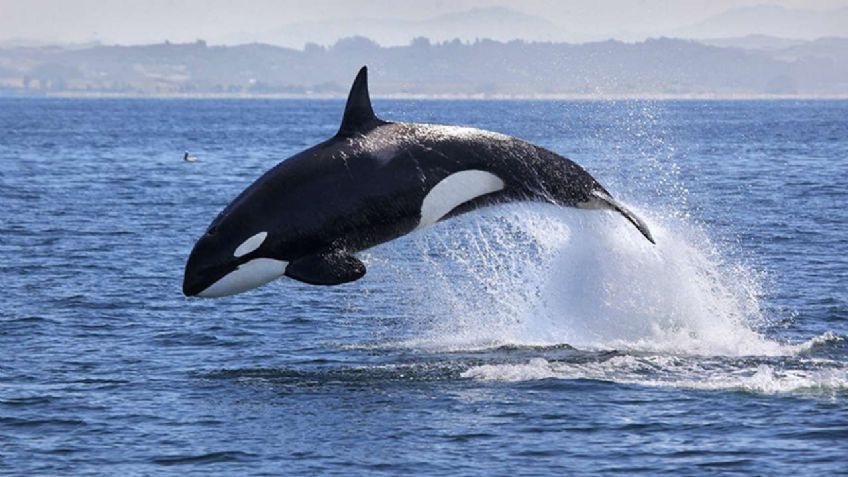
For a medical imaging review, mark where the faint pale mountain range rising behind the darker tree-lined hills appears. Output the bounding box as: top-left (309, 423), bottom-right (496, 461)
top-left (181, 2), bottom-right (848, 49)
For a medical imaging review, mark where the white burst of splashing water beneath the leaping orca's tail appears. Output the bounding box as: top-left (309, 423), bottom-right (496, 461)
top-left (384, 204), bottom-right (786, 355)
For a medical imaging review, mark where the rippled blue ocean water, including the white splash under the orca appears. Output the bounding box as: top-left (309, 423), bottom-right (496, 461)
top-left (0, 99), bottom-right (848, 475)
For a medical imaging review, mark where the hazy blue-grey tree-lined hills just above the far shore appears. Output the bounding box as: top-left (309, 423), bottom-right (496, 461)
top-left (0, 37), bottom-right (848, 97)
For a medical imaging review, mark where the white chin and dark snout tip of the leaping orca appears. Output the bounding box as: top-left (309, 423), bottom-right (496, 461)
top-left (183, 258), bottom-right (287, 298)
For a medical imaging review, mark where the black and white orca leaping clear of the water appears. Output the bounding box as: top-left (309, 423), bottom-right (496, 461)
top-left (183, 67), bottom-right (654, 298)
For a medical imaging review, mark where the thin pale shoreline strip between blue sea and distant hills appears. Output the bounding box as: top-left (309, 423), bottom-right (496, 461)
top-left (0, 92), bottom-right (848, 101)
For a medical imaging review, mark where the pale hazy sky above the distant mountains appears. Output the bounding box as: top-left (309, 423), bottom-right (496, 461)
top-left (0, 0), bottom-right (848, 44)
